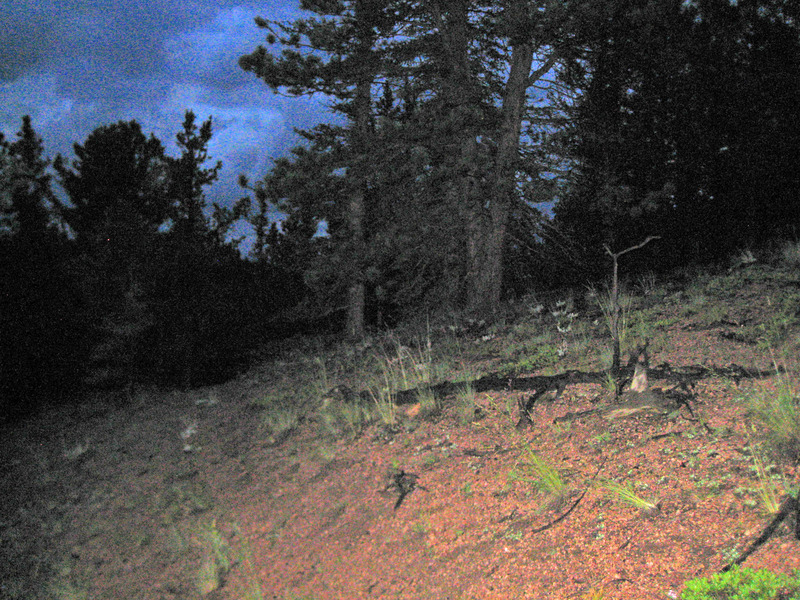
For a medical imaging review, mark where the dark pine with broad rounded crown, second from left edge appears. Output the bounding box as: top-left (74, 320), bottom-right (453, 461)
top-left (54, 121), bottom-right (170, 391)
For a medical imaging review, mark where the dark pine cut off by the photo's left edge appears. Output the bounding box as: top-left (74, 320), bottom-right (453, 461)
top-left (0, 116), bottom-right (83, 415)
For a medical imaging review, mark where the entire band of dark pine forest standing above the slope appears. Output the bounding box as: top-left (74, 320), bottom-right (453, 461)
top-left (0, 0), bottom-right (800, 419)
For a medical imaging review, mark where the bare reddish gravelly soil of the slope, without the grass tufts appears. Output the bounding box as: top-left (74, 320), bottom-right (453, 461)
top-left (0, 290), bottom-right (800, 600)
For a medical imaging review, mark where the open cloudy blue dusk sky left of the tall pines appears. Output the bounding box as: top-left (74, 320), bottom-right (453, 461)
top-left (0, 0), bottom-right (328, 246)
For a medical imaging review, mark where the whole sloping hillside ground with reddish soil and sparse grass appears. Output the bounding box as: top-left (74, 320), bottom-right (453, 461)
top-left (0, 265), bottom-right (800, 600)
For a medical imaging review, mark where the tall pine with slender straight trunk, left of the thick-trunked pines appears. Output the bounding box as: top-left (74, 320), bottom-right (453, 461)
top-left (239, 0), bottom-right (398, 338)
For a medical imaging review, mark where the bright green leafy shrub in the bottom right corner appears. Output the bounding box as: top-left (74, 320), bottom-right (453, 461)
top-left (681, 567), bottom-right (800, 600)
